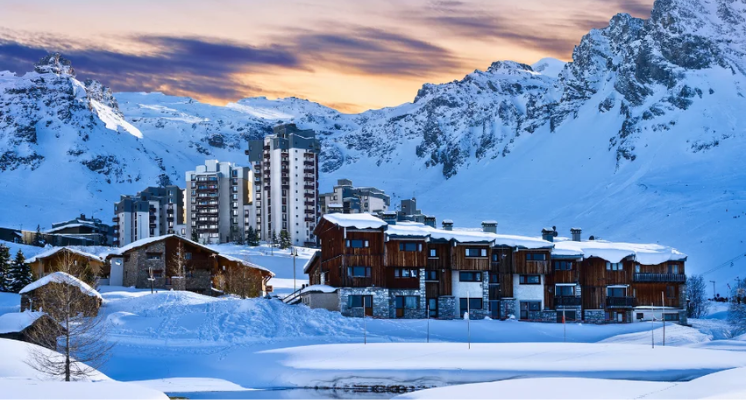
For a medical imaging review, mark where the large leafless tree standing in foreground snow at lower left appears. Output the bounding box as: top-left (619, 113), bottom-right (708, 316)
top-left (28, 255), bottom-right (113, 381)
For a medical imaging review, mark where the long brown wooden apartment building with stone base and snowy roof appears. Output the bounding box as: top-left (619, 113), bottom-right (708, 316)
top-left (305, 214), bottom-right (686, 322)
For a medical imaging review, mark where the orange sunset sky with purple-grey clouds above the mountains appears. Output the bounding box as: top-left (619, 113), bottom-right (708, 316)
top-left (0, 0), bottom-right (653, 113)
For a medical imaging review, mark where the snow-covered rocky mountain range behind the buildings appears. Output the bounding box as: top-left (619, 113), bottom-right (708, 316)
top-left (0, 0), bottom-right (746, 290)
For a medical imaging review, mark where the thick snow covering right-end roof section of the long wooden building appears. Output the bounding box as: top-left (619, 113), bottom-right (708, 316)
top-left (553, 240), bottom-right (687, 265)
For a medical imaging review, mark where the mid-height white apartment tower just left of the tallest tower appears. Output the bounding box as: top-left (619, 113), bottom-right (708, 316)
top-left (185, 160), bottom-right (254, 243)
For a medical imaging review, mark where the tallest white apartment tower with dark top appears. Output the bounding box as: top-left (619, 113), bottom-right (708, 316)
top-left (246, 124), bottom-right (321, 246)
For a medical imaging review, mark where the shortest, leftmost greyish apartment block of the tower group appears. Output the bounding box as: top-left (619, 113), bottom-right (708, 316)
top-left (112, 185), bottom-right (184, 246)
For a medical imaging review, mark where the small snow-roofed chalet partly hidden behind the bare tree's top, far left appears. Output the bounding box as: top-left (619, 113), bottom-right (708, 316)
top-left (26, 247), bottom-right (109, 278)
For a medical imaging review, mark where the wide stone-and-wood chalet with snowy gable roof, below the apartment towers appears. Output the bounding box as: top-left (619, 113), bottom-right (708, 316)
top-left (107, 234), bottom-right (274, 297)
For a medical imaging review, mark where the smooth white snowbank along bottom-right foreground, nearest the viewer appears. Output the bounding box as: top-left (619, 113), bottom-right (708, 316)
top-left (395, 368), bottom-right (746, 399)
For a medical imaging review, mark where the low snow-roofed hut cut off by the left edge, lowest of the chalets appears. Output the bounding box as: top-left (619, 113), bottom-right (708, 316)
top-left (0, 311), bottom-right (64, 350)
